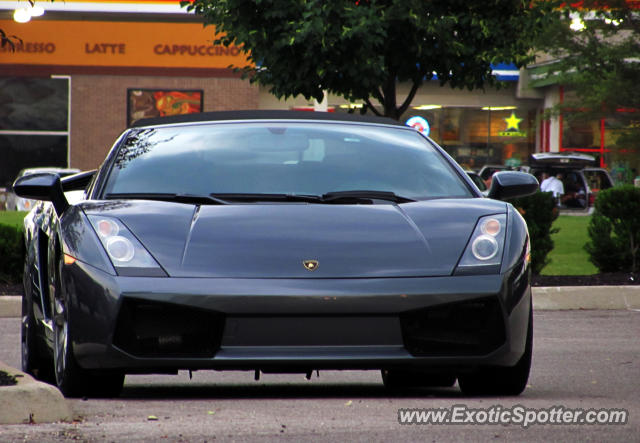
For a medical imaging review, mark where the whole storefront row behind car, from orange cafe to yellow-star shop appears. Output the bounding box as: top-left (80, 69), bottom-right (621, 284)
top-left (6, 0), bottom-right (632, 186)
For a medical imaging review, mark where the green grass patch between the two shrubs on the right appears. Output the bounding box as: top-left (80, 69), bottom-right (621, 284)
top-left (541, 215), bottom-right (598, 275)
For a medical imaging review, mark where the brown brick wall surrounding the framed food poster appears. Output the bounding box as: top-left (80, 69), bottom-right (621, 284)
top-left (69, 75), bottom-right (259, 170)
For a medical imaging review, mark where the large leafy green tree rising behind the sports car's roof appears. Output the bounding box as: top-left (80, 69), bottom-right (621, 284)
top-left (183, 0), bottom-right (554, 119)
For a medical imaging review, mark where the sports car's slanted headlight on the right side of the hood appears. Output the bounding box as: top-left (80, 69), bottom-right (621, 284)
top-left (455, 214), bottom-right (507, 275)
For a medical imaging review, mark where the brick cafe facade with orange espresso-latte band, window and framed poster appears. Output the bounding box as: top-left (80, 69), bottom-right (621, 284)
top-left (0, 9), bottom-right (259, 186)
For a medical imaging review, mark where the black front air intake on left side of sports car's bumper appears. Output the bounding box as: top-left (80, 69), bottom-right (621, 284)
top-left (113, 298), bottom-right (224, 358)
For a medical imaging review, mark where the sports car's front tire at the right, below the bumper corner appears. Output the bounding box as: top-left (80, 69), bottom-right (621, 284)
top-left (458, 309), bottom-right (533, 396)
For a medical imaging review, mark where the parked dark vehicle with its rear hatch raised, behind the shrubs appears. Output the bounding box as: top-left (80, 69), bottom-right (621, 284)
top-left (529, 152), bottom-right (614, 211)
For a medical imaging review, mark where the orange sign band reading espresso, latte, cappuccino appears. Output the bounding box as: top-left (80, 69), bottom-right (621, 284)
top-left (0, 20), bottom-right (248, 72)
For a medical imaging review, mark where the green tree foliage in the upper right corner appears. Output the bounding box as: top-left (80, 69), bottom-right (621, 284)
top-left (534, 0), bottom-right (640, 147)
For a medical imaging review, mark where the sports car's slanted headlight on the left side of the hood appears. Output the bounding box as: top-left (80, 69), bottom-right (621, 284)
top-left (87, 215), bottom-right (166, 276)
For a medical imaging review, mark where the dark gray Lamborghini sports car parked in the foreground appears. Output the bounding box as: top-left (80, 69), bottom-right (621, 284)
top-left (14, 111), bottom-right (538, 396)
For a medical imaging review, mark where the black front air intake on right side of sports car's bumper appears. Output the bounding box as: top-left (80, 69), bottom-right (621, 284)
top-left (400, 297), bottom-right (505, 357)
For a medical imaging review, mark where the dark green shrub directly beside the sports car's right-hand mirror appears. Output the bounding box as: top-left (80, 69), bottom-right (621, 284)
top-left (510, 192), bottom-right (558, 274)
